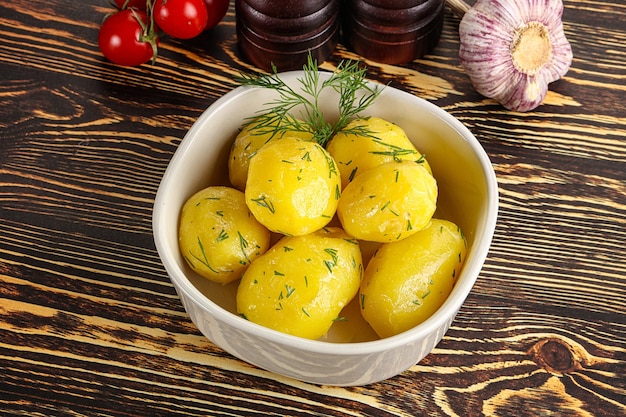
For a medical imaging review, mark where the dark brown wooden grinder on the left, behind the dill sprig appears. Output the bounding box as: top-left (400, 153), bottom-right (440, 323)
top-left (235, 0), bottom-right (340, 71)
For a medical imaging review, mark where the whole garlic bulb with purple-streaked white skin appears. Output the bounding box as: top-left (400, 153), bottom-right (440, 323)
top-left (459, 0), bottom-right (573, 112)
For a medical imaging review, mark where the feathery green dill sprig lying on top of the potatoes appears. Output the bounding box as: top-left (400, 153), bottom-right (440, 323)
top-left (235, 54), bottom-right (382, 146)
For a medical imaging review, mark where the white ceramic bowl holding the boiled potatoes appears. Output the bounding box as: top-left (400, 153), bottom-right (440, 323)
top-left (153, 71), bottom-right (498, 386)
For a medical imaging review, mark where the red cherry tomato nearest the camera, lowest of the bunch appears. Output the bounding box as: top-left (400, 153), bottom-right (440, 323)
top-left (98, 9), bottom-right (158, 66)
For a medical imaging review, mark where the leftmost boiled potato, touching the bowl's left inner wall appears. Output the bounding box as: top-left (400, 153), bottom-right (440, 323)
top-left (178, 186), bottom-right (270, 284)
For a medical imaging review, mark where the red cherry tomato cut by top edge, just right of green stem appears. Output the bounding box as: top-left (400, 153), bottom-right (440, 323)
top-left (154, 0), bottom-right (209, 39)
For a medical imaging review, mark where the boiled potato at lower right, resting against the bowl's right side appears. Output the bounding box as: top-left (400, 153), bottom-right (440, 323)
top-left (359, 219), bottom-right (467, 337)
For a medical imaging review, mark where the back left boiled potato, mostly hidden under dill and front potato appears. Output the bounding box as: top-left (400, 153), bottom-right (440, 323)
top-left (228, 116), bottom-right (313, 191)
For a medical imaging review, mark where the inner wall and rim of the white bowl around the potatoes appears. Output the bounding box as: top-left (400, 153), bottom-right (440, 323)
top-left (154, 71), bottom-right (497, 343)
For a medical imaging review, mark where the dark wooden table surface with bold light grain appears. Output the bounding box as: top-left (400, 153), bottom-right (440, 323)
top-left (0, 0), bottom-right (626, 417)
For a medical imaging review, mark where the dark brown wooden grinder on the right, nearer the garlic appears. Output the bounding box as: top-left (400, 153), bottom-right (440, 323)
top-left (341, 0), bottom-right (444, 64)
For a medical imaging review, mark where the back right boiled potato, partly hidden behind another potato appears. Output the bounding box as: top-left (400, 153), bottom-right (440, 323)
top-left (326, 117), bottom-right (431, 188)
